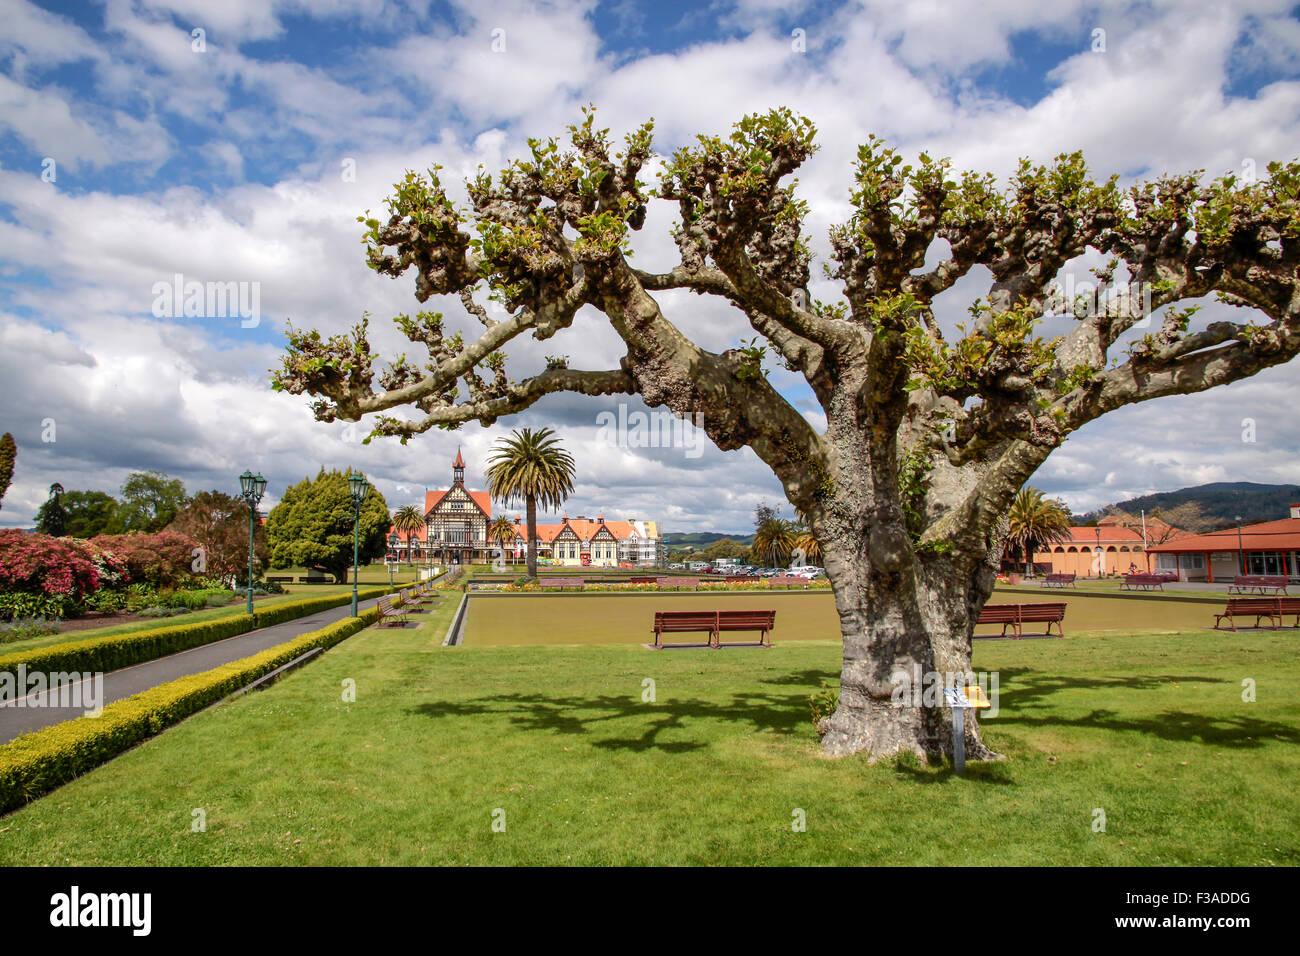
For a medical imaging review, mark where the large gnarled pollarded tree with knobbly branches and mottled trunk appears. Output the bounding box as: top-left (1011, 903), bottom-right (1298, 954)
top-left (274, 109), bottom-right (1300, 757)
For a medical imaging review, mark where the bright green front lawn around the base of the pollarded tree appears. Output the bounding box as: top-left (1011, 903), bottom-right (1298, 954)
top-left (0, 606), bottom-right (1300, 866)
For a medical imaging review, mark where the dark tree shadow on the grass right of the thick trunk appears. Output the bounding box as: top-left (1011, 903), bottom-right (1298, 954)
top-left (982, 670), bottom-right (1300, 748)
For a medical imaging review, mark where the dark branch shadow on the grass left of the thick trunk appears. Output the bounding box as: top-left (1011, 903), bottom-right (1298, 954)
top-left (411, 693), bottom-right (813, 753)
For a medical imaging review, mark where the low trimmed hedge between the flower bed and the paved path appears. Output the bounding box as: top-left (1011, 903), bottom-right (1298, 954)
top-left (0, 587), bottom-right (389, 674)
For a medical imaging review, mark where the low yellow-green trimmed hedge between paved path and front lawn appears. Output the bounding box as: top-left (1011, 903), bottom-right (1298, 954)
top-left (0, 609), bottom-right (378, 813)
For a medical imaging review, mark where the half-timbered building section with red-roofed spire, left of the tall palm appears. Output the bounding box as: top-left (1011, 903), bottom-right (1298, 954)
top-left (389, 449), bottom-right (497, 564)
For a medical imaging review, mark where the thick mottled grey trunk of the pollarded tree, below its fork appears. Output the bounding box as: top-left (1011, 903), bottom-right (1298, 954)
top-left (819, 544), bottom-right (1000, 761)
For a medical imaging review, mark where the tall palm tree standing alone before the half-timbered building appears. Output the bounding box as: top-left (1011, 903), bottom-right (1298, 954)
top-left (486, 428), bottom-right (573, 578)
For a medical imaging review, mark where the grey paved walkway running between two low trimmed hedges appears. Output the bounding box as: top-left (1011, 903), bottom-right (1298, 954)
top-left (0, 598), bottom-right (378, 744)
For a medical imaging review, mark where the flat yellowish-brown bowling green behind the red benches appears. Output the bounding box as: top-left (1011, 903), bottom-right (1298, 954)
top-left (463, 591), bottom-right (1222, 645)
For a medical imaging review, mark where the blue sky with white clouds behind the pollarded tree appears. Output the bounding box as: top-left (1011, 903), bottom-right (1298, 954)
top-left (0, 0), bottom-right (1300, 531)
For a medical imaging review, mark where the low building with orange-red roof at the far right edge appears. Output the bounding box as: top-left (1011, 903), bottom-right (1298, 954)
top-left (1149, 503), bottom-right (1300, 581)
